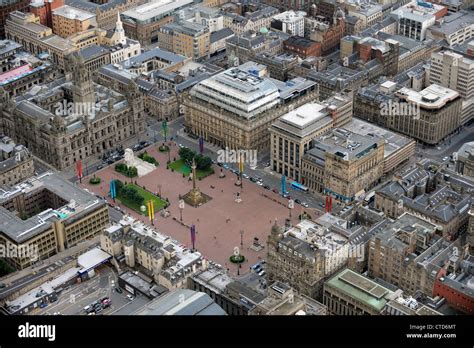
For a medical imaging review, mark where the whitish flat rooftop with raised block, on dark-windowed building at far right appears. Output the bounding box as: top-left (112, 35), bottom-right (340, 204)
top-left (395, 84), bottom-right (459, 110)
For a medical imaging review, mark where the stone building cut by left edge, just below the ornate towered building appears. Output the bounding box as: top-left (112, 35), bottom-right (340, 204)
top-left (0, 136), bottom-right (35, 187)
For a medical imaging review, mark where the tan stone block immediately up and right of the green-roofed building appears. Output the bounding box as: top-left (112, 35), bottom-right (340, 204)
top-left (368, 213), bottom-right (463, 297)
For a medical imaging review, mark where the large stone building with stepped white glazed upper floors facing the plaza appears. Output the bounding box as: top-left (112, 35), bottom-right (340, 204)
top-left (184, 62), bottom-right (318, 152)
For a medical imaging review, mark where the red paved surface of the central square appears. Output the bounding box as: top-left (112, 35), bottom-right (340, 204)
top-left (83, 145), bottom-right (303, 273)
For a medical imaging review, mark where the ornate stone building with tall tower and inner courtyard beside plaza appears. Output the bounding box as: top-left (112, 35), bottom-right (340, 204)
top-left (1, 55), bottom-right (145, 170)
